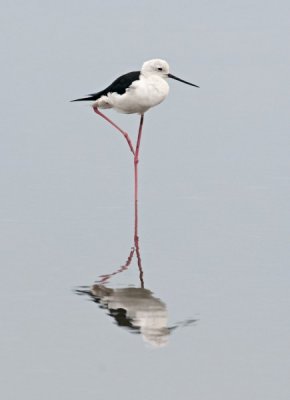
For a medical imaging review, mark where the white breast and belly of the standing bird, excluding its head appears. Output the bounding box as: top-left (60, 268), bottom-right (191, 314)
top-left (106, 77), bottom-right (169, 114)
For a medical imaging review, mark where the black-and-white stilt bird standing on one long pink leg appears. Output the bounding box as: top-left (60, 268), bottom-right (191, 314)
top-left (71, 59), bottom-right (199, 236)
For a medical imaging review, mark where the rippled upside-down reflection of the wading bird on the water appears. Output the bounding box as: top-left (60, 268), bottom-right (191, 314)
top-left (77, 236), bottom-right (196, 347)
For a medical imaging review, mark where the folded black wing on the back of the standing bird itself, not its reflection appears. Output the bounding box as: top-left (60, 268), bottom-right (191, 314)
top-left (72, 71), bottom-right (140, 101)
